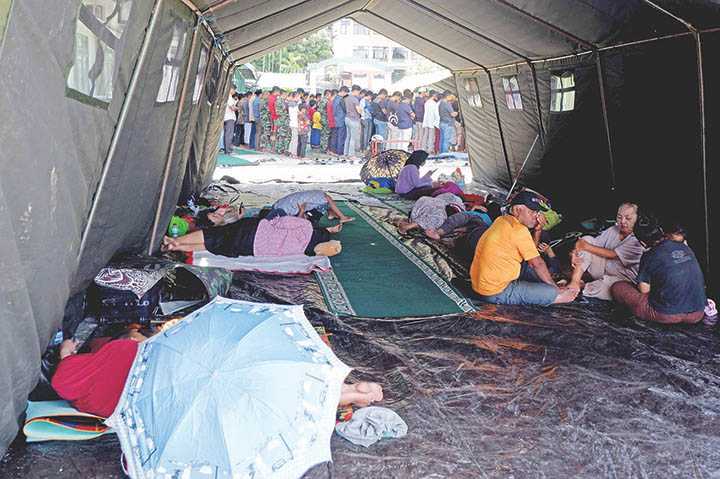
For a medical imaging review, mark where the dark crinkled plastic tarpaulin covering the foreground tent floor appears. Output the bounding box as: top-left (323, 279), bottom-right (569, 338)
top-left (0, 273), bottom-right (720, 479)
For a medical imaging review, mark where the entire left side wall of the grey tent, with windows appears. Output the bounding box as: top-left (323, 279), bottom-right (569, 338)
top-left (0, 0), bottom-right (229, 451)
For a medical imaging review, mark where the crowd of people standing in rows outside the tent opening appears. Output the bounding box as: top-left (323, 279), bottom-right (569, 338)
top-left (221, 85), bottom-right (465, 158)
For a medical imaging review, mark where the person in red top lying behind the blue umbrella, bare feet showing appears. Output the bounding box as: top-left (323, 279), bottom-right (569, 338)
top-left (52, 330), bottom-right (383, 417)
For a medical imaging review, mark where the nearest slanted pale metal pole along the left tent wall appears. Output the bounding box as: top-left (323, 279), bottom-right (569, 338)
top-left (77, 0), bottom-right (163, 260)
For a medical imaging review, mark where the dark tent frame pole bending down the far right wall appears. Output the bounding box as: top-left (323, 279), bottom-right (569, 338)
top-left (643, 0), bottom-right (712, 277)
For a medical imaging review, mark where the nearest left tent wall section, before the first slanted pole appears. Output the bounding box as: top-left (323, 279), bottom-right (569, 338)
top-left (0, 0), bottom-right (158, 450)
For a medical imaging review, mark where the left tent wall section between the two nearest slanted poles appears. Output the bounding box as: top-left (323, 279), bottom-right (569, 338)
top-left (76, 0), bottom-right (195, 286)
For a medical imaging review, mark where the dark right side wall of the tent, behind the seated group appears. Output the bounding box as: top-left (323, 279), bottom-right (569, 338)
top-left (455, 33), bottom-right (720, 290)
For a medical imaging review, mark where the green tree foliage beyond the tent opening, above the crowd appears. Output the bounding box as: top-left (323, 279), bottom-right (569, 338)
top-left (252, 33), bottom-right (333, 73)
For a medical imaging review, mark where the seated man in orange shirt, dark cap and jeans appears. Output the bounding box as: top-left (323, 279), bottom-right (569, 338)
top-left (470, 191), bottom-right (578, 306)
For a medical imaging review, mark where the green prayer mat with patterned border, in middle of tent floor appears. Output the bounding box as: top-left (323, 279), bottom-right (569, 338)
top-left (315, 202), bottom-right (474, 318)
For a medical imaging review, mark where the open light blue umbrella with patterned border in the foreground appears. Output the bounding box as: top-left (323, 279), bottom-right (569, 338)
top-left (107, 297), bottom-right (350, 479)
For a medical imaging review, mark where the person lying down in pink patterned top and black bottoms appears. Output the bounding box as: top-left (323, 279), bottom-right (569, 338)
top-left (162, 216), bottom-right (342, 258)
